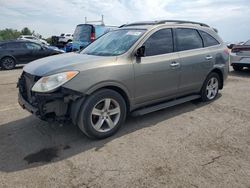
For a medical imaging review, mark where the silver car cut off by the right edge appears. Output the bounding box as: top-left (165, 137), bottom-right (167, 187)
top-left (230, 40), bottom-right (250, 71)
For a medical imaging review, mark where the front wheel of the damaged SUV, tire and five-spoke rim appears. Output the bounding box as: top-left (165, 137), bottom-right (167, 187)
top-left (78, 89), bottom-right (126, 139)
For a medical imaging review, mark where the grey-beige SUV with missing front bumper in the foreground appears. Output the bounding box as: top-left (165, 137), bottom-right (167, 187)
top-left (18, 20), bottom-right (229, 139)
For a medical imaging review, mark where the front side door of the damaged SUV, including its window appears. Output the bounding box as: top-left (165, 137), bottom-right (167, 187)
top-left (134, 29), bottom-right (180, 103)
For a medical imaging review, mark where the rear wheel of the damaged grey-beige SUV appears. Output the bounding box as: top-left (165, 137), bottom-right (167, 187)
top-left (201, 72), bottom-right (221, 102)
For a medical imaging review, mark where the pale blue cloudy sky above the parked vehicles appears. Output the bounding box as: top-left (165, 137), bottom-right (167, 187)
top-left (0, 0), bottom-right (250, 42)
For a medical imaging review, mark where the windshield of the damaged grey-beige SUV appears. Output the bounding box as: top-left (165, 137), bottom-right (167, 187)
top-left (81, 29), bottom-right (145, 56)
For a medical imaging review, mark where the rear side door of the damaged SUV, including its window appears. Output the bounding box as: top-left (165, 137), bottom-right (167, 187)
top-left (175, 28), bottom-right (213, 95)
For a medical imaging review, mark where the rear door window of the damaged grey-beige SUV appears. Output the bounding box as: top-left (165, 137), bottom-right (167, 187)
top-left (176, 28), bottom-right (203, 51)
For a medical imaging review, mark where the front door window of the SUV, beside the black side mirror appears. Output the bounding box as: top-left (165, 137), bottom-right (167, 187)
top-left (144, 29), bottom-right (174, 56)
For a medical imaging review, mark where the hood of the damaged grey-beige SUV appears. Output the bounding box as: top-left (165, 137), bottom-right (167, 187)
top-left (23, 53), bottom-right (116, 76)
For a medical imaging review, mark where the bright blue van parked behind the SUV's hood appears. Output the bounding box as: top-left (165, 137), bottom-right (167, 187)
top-left (72, 24), bottom-right (116, 51)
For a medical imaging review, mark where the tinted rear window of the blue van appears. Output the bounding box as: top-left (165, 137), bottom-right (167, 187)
top-left (74, 25), bottom-right (92, 42)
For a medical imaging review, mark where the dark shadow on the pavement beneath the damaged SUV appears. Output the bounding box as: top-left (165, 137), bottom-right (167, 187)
top-left (0, 95), bottom-right (221, 172)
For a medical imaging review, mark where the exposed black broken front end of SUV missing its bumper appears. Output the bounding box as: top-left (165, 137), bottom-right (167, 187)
top-left (17, 72), bottom-right (84, 124)
